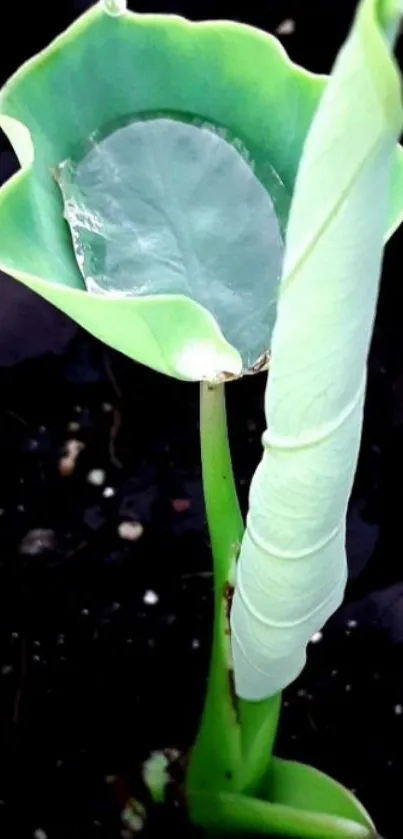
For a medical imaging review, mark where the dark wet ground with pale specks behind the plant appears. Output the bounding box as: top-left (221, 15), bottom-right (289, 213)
top-left (0, 0), bottom-right (403, 839)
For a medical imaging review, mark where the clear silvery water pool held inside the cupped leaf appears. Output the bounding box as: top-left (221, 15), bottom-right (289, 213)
top-left (54, 113), bottom-right (289, 370)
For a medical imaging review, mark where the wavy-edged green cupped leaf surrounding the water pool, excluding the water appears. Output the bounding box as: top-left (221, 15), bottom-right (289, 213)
top-left (0, 5), bottom-right (325, 379)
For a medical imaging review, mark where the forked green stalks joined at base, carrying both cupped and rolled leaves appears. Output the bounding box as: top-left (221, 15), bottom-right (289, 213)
top-left (187, 383), bottom-right (280, 813)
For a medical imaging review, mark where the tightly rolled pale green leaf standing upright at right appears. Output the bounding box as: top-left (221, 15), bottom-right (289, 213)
top-left (231, 0), bottom-right (403, 701)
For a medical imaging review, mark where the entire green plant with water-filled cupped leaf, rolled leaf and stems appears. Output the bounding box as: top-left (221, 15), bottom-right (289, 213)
top-left (0, 0), bottom-right (403, 839)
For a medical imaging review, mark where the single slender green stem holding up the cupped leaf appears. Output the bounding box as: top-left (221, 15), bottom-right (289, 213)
top-left (187, 382), bottom-right (243, 790)
